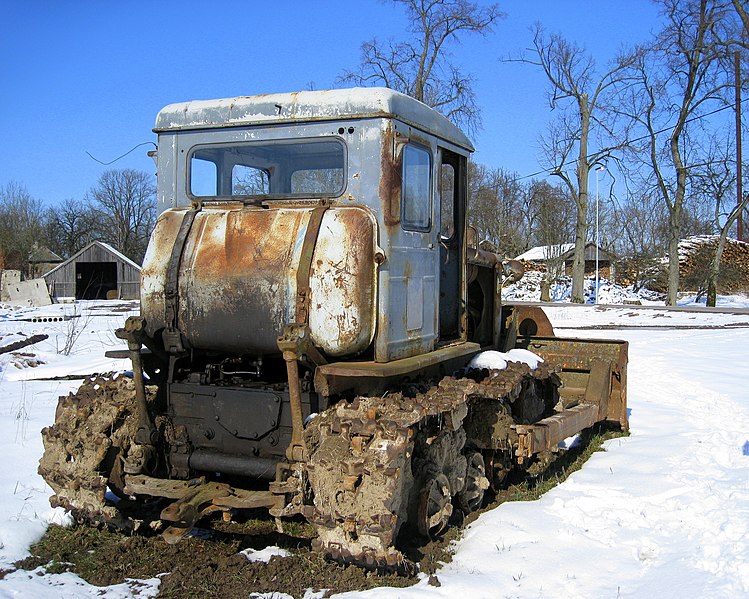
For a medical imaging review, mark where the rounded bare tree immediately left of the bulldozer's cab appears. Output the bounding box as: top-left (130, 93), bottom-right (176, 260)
top-left (87, 169), bottom-right (156, 262)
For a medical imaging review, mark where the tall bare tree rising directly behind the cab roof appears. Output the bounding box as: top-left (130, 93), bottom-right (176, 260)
top-left (338, 0), bottom-right (504, 133)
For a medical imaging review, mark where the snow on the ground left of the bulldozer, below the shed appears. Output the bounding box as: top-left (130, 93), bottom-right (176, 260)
top-left (0, 301), bottom-right (158, 598)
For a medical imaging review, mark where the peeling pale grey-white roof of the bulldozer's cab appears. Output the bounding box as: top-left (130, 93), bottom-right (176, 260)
top-left (154, 87), bottom-right (474, 152)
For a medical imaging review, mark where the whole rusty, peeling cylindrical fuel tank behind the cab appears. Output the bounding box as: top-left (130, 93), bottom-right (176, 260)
top-left (141, 201), bottom-right (381, 357)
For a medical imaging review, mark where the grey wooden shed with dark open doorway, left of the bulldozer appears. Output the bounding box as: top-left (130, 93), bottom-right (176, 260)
top-left (43, 241), bottom-right (140, 299)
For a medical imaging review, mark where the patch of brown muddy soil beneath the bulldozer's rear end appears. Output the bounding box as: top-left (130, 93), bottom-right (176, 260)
top-left (14, 519), bottom-right (416, 599)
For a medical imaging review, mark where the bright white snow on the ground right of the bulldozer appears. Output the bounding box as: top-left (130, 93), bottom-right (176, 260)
top-left (343, 306), bottom-right (749, 599)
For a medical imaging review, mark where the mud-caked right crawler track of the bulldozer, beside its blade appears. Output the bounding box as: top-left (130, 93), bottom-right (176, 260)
top-left (305, 363), bottom-right (559, 566)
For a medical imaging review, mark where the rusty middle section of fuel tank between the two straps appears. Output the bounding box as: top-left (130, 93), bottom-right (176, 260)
top-left (179, 204), bottom-right (309, 354)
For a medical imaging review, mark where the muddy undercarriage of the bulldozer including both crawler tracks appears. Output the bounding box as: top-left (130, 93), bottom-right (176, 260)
top-left (39, 332), bottom-right (624, 567)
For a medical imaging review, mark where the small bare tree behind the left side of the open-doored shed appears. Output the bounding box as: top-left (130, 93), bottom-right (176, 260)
top-left (44, 198), bottom-right (98, 258)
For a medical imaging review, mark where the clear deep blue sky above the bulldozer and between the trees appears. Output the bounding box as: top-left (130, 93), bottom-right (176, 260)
top-left (0, 0), bottom-right (658, 205)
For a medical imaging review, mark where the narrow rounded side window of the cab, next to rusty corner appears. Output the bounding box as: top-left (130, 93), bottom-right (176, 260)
top-left (401, 144), bottom-right (432, 231)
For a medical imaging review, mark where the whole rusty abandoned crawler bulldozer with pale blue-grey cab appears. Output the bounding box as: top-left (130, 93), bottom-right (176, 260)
top-left (39, 88), bottom-right (627, 566)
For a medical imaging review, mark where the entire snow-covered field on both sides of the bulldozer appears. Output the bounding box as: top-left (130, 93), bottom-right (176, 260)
top-left (0, 298), bottom-right (749, 599)
